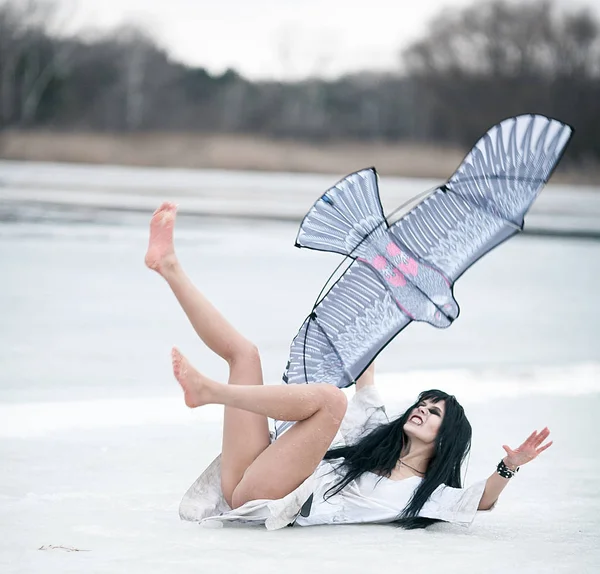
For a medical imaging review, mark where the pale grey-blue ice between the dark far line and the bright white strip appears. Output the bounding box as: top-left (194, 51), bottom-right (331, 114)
top-left (0, 213), bottom-right (600, 402)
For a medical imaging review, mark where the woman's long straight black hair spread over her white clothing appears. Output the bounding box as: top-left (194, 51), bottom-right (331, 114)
top-left (324, 389), bottom-right (471, 529)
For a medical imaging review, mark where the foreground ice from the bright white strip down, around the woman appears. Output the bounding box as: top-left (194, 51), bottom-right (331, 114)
top-left (0, 380), bottom-right (600, 574)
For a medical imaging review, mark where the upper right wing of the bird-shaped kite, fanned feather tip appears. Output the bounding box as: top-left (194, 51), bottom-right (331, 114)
top-left (391, 115), bottom-right (573, 283)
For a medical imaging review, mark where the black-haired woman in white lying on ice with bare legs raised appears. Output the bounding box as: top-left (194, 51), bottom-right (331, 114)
top-left (146, 203), bottom-right (552, 529)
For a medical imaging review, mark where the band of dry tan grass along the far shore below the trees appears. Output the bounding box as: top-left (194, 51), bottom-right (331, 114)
top-left (0, 131), bottom-right (600, 183)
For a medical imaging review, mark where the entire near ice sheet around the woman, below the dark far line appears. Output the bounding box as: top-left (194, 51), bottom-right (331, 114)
top-left (0, 164), bottom-right (600, 574)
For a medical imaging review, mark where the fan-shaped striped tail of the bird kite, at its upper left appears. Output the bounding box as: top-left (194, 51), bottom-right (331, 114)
top-left (296, 168), bottom-right (388, 257)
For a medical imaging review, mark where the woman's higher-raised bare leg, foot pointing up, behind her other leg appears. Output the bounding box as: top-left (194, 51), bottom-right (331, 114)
top-left (145, 203), bottom-right (270, 505)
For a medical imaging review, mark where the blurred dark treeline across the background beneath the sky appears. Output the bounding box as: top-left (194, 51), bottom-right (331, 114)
top-left (0, 0), bottom-right (600, 160)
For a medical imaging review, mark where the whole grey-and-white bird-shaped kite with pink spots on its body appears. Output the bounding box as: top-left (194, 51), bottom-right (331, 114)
top-left (284, 115), bottom-right (572, 418)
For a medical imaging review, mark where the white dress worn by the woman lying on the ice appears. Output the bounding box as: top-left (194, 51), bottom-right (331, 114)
top-left (179, 386), bottom-right (485, 530)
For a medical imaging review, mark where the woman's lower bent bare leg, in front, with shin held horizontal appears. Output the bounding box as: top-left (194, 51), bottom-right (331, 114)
top-left (172, 349), bottom-right (346, 508)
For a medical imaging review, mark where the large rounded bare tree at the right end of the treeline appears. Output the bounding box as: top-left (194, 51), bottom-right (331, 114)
top-left (402, 0), bottom-right (600, 158)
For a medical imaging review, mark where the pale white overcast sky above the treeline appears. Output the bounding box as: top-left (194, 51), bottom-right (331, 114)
top-left (60, 0), bottom-right (600, 79)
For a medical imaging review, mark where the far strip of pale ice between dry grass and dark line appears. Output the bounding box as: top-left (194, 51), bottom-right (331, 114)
top-left (0, 160), bottom-right (600, 238)
